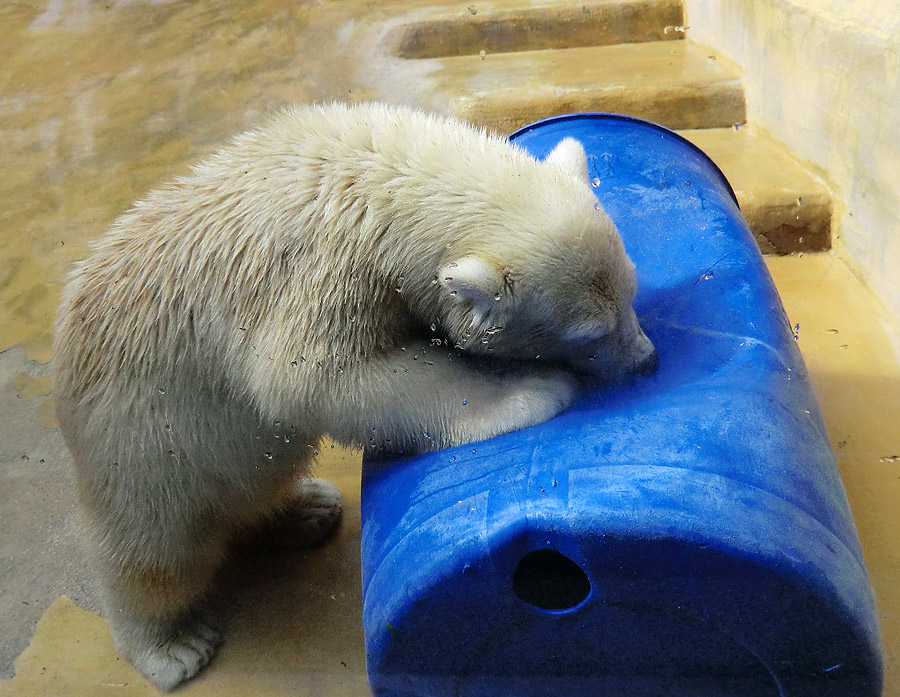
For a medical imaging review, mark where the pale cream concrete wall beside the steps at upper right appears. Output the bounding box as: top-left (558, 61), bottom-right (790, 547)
top-left (685, 0), bottom-right (900, 317)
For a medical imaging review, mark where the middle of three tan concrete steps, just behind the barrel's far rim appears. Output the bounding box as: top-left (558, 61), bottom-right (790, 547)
top-left (418, 41), bottom-right (745, 133)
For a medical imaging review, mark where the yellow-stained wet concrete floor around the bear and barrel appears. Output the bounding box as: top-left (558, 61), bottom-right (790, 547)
top-left (0, 0), bottom-right (900, 697)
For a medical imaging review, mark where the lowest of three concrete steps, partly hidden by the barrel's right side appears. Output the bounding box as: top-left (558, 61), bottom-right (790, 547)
top-left (681, 126), bottom-right (831, 254)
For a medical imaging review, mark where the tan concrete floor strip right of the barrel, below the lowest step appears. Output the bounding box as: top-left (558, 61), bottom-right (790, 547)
top-left (767, 254), bottom-right (900, 697)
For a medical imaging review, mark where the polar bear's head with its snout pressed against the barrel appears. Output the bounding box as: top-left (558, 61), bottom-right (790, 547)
top-left (439, 139), bottom-right (657, 379)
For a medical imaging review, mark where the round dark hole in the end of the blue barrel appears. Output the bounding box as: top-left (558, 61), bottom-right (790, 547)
top-left (513, 549), bottom-right (591, 610)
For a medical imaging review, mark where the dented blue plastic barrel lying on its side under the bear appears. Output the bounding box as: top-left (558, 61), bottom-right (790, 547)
top-left (362, 114), bottom-right (881, 697)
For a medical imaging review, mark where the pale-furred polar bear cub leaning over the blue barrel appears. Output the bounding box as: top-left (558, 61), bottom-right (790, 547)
top-left (54, 104), bottom-right (655, 690)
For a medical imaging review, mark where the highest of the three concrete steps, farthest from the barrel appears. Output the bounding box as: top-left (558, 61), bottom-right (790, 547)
top-left (388, 0), bottom-right (684, 58)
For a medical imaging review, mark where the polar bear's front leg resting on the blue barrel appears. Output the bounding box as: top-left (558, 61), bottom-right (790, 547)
top-left (331, 342), bottom-right (577, 453)
